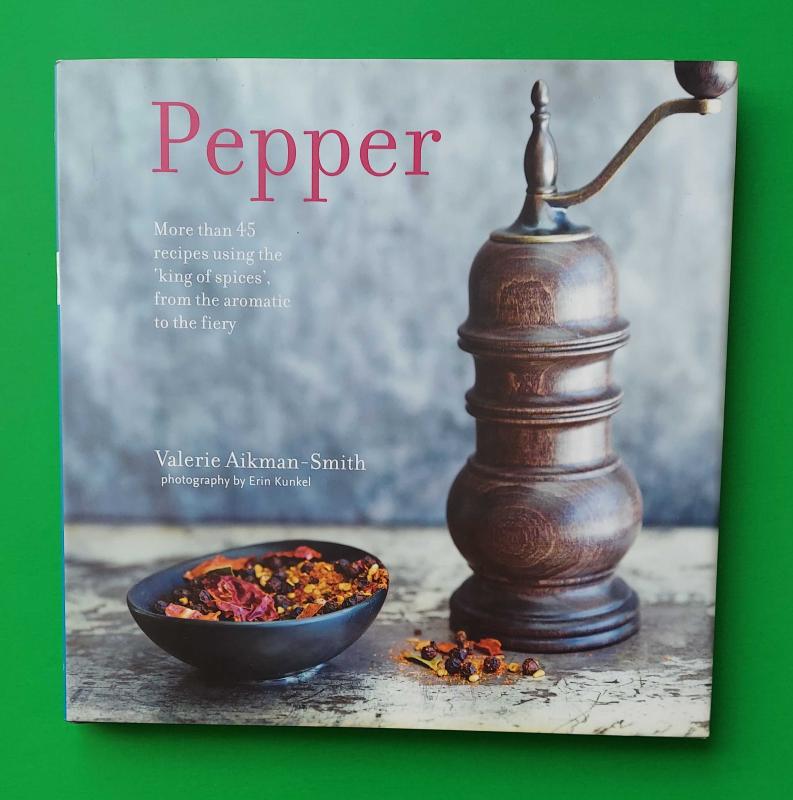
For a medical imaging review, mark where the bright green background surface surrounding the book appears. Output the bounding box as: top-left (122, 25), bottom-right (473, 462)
top-left (0, 0), bottom-right (793, 800)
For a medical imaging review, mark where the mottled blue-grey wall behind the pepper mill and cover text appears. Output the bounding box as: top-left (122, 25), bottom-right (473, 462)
top-left (58, 61), bottom-right (735, 523)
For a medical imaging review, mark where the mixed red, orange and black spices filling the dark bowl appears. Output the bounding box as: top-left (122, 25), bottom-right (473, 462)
top-left (156, 545), bottom-right (388, 620)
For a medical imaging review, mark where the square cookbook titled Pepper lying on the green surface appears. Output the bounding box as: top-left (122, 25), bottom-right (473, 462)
top-left (57, 59), bottom-right (736, 737)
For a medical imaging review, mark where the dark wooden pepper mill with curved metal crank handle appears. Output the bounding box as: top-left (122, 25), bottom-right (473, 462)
top-left (447, 61), bottom-right (737, 652)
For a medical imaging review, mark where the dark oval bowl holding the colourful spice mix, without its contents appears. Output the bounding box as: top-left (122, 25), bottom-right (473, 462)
top-left (127, 539), bottom-right (387, 680)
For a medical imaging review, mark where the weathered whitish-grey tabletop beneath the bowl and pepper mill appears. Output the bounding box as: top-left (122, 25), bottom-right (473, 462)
top-left (66, 525), bottom-right (717, 737)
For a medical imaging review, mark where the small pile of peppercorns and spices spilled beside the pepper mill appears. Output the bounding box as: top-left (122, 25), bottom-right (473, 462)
top-left (402, 630), bottom-right (545, 683)
